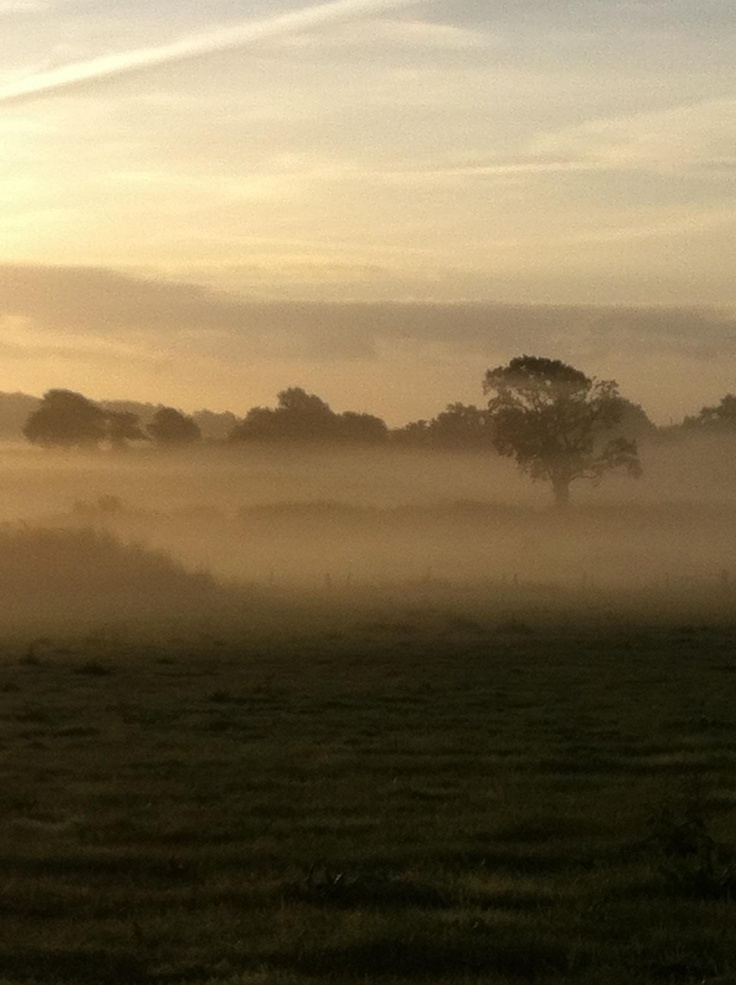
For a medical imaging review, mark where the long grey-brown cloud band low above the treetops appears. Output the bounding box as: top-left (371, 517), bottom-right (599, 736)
top-left (0, 264), bottom-right (736, 362)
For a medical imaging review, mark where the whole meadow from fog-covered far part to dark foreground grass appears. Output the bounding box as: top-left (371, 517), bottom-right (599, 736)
top-left (0, 442), bottom-right (736, 985)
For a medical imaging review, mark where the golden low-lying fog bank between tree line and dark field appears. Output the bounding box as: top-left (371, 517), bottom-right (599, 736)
top-left (0, 440), bottom-right (736, 600)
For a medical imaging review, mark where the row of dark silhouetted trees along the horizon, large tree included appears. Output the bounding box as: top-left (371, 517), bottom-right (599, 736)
top-left (17, 355), bottom-right (736, 507)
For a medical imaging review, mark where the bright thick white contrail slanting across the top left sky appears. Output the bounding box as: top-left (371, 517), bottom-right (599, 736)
top-left (0, 0), bottom-right (425, 105)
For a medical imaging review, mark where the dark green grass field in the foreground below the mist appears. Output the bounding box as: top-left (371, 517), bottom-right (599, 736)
top-left (0, 596), bottom-right (736, 985)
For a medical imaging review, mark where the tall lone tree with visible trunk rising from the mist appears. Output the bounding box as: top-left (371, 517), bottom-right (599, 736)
top-left (483, 356), bottom-right (641, 509)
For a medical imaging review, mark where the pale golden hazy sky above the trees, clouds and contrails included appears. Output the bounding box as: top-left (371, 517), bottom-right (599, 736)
top-left (0, 0), bottom-right (736, 424)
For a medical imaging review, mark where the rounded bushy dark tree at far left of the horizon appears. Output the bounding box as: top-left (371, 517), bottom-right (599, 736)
top-left (23, 390), bottom-right (107, 448)
